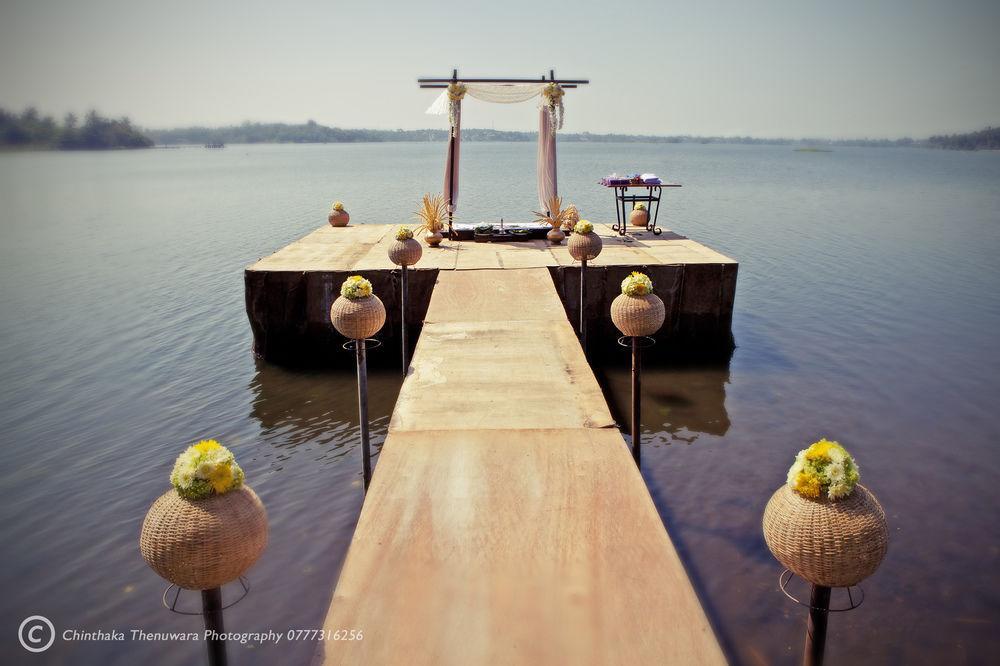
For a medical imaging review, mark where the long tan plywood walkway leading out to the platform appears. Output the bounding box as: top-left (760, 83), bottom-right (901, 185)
top-left (317, 268), bottom-right (725, 666)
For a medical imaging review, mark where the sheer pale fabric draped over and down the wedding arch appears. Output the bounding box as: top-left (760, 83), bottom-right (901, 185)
top-left (427, 81), bottom-right (559, 213)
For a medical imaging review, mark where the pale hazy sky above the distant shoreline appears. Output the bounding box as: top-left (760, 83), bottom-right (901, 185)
top-left (0, 0), bottom-right (1000, 138)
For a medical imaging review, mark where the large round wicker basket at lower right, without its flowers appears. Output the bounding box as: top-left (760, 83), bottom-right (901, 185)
top-left (764, 484), bottom-right (889, 587)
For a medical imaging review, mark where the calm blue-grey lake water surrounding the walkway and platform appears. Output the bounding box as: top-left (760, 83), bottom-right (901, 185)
top-left (0, 143), bottom-right (1000, 665)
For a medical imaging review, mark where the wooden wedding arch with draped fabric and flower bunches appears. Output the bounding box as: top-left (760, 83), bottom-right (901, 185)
top-left (417, 69), bottom-right (590, 236)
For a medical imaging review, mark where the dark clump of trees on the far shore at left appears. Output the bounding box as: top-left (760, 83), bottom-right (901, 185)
top-left (0, 107), bottom-right (153, 150)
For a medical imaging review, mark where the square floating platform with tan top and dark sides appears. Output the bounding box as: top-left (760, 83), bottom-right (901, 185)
top-left (245, 224), bottom-right (739, 365)
